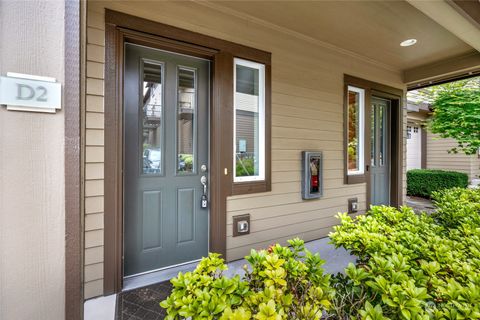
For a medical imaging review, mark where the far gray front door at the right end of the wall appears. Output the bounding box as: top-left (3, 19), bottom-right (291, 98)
top-left (370, 97), bottom-right (390, 205)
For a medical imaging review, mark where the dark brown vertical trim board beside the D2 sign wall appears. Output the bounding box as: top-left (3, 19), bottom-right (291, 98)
top-left (64, 0), bottom-right (83, 320)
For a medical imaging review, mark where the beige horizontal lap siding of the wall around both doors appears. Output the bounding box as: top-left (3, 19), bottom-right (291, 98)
top-left (85, 1), bottom-right (406, 297)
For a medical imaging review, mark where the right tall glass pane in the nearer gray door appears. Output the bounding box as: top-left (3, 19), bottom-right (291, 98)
top-left (177, 68), bottom-right (197, 174)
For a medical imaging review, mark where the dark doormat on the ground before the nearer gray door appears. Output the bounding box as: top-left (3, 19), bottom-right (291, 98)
top-left (115, 281), bottom-right (172, 320)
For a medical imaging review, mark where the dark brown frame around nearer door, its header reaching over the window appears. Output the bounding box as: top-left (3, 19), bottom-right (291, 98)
top-left (104, 10), bottom-right (271, 294)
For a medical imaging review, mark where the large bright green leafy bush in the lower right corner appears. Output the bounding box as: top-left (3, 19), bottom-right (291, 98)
top-left (330, 198), bottom-right (480, 319)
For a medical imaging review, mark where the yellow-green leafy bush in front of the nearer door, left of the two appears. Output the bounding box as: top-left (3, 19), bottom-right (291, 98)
top-left (160, 239), bottom-right (333, 320)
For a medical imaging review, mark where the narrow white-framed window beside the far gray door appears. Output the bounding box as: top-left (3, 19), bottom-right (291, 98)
top-left (347, 86), bottom-right (365, 175)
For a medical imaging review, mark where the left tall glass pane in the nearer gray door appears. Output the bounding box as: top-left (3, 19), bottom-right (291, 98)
top-left (142, 61), bottom-right (163, 174)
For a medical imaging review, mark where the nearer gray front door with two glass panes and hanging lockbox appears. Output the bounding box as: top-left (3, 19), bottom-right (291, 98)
top-left (124, 44), bottom-right (210, 276)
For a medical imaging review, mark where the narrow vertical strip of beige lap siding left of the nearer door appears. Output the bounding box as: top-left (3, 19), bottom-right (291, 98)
top-left (84, 5), bottom-right (105, 299)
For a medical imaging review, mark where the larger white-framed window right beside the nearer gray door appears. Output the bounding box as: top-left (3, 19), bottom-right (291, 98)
top-left (233, 58), bottom-right (265, 182)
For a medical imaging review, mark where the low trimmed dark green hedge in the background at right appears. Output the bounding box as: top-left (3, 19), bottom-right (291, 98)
top-left (407, 169), bottom-right (468, 198)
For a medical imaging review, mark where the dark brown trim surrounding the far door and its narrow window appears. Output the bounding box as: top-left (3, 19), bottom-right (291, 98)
top-left (343, 74), bottom-right (404, 208)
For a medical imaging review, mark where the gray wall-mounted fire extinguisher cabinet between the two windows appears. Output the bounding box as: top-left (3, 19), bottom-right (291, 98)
top-left (302, 151), bottom-right (323, 199)
